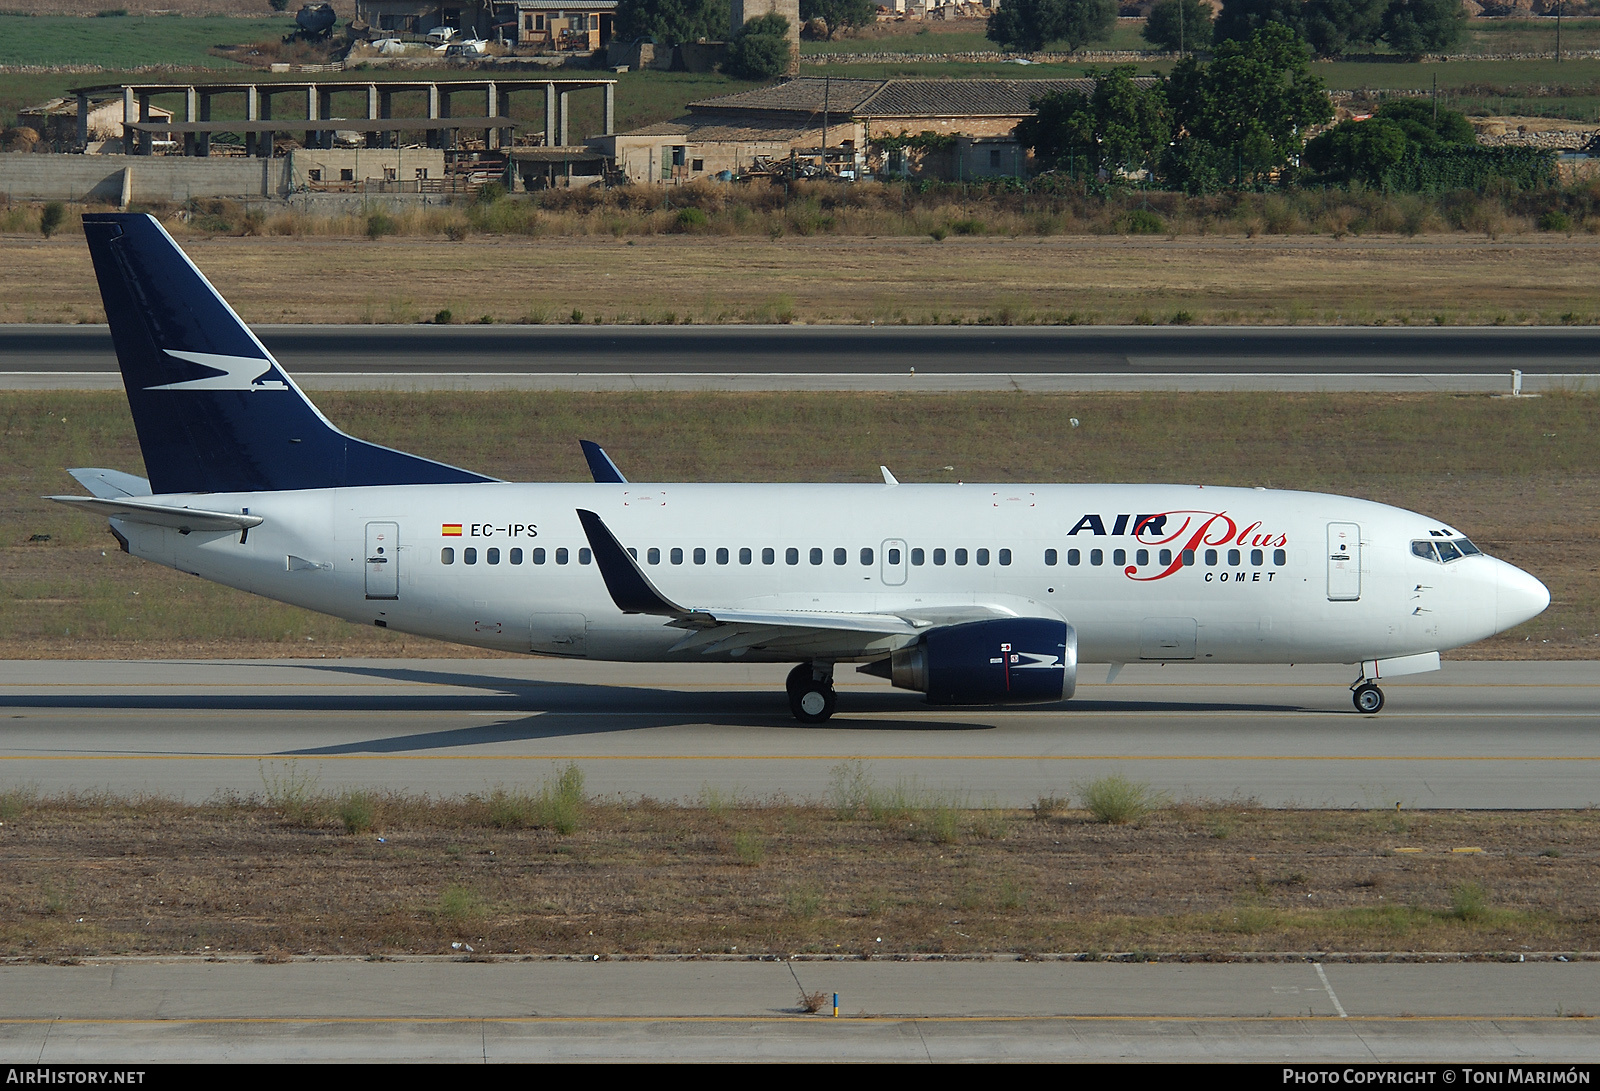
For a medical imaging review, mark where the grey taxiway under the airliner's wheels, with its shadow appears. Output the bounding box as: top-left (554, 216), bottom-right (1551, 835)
top-left (0, 659), bottom-right (1600, 808)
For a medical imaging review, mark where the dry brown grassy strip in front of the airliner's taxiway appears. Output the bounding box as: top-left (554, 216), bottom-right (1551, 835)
top-left (0, 795), bottom-right (1600, 958)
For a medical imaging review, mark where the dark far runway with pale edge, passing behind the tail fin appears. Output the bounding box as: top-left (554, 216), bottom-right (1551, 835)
top-left (0, 325), bottom-right (1600, 390)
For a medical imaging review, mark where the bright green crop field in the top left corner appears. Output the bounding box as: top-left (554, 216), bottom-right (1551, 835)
top-left (0, 16), bottom-right (294, 69)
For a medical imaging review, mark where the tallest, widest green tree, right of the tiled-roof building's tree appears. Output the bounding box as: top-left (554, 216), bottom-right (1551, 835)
top-left (1166, 24), bottom-right (1333, 184)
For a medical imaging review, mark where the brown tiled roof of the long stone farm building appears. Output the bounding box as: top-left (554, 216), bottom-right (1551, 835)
top-left (690, 75), bottom-right (1149, 118)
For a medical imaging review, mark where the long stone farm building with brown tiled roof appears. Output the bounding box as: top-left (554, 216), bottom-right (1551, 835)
top-left (594, 77), bottom-right (1093, 182)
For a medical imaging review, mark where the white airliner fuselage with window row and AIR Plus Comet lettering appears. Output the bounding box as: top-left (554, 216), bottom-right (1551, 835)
top-left (115, 483), bottom-right (1549, 664)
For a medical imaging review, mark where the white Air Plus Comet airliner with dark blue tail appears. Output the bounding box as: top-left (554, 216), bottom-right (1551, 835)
top-left (51, 213), bottom-right (1550, 721)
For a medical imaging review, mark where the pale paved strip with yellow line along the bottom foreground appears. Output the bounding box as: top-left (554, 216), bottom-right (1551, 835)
top-left (0, 957), bottom-right (1600, 1055)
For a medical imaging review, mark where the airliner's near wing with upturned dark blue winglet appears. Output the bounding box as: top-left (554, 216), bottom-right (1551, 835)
top-left (578, 510), bottom-right (1036, 659)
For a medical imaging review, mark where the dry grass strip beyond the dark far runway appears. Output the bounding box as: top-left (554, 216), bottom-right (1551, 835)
top-left (9, 234), bottom-right (1600, 325)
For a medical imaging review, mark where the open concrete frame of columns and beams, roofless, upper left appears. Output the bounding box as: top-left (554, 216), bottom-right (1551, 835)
top-left (72, 78), bottom-right (616, 158)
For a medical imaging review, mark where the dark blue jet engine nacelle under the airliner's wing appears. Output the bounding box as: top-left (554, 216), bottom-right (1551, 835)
top-left (862, 617), bottom-right (1078, 704)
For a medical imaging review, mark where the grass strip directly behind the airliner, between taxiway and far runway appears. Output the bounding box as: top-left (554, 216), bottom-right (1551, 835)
top-left (0, 392), bottom-right (1600, 659)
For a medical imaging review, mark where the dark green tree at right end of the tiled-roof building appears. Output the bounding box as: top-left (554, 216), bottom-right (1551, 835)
top-left (1016, 64), bottom-right (1171, 171)
